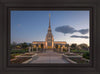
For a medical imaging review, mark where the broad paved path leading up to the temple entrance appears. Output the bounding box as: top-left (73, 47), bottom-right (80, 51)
top-left (30, 50), bottom-right (69, 63)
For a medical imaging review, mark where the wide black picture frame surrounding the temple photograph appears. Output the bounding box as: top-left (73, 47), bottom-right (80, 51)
top-left (0, 0), bottom-right (100, 74)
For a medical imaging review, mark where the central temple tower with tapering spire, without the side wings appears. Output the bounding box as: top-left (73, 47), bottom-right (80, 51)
top-left (45, 14), bottom-right (54, 49)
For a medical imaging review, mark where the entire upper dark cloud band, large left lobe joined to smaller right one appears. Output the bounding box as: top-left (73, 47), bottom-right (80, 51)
top-left (55, 25), bottom-right (88, 34)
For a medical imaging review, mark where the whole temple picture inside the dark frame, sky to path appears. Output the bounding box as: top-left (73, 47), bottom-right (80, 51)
top-left (8, 10), bottom-right (91, 64)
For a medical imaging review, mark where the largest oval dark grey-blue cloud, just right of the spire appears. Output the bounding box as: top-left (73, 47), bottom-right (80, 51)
top-left (55, 25), bottom-right (76, 34)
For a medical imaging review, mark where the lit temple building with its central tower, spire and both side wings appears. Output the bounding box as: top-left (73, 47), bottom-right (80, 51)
top-left (32, 14), bottom-right (67, 49)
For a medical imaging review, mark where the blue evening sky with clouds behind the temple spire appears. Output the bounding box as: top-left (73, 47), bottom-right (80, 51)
top-left (10, 10), bottom-right (90, 45)
